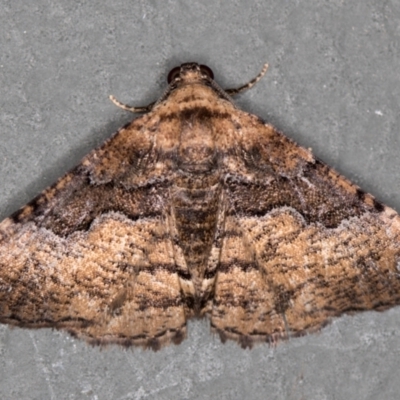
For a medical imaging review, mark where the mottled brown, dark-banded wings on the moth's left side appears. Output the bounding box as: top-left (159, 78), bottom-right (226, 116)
top-left (0, 113), bottom-right (186, 348)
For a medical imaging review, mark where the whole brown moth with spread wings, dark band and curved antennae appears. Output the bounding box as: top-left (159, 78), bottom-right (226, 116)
top-left (0, 63), bottom-right (400, 350)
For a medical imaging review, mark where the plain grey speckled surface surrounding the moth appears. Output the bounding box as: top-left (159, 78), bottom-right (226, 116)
top-left (0, 0), bottom-right (400, 400)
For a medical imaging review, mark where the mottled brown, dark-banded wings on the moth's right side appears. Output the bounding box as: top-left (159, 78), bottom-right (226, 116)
top-left (211, 113), bottom-right (400, 346)
